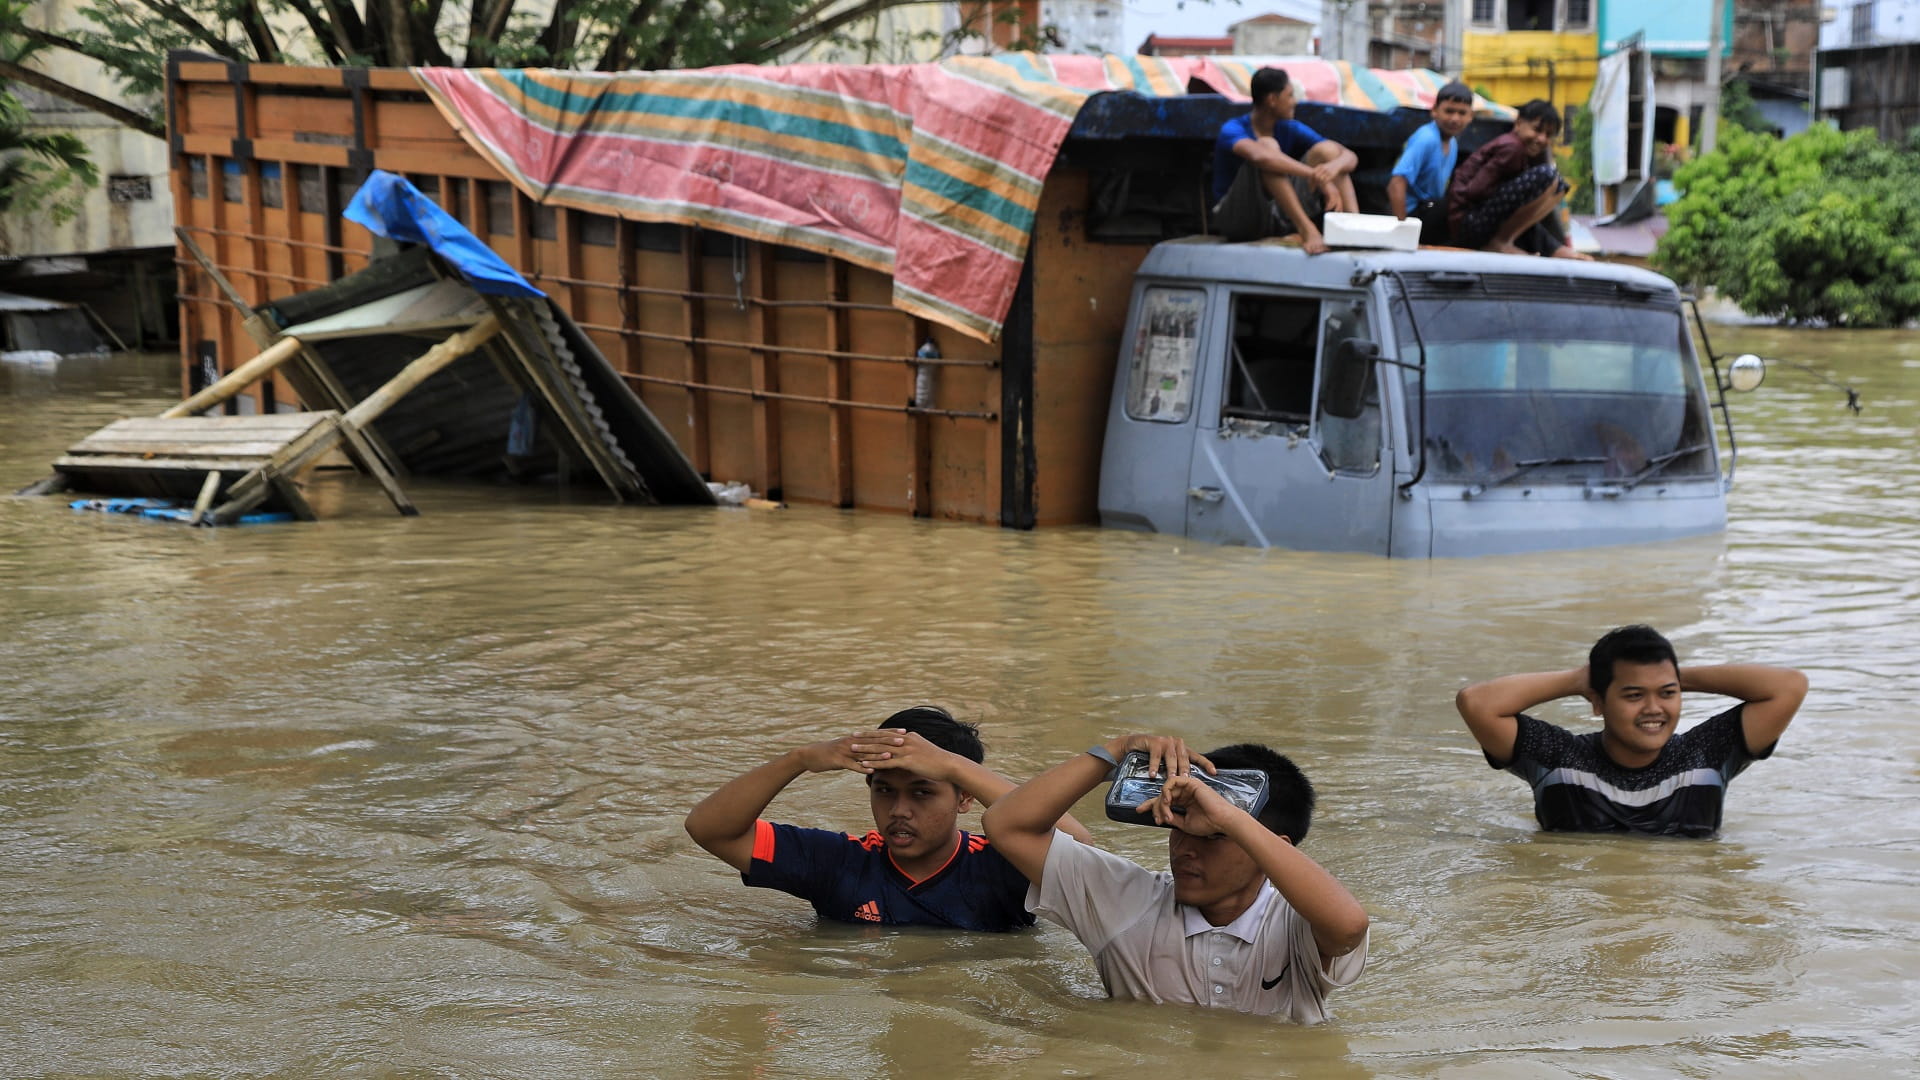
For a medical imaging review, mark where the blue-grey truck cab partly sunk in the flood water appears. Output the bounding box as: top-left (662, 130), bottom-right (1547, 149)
top-left (1100, 238), bottom-right (1726, 557)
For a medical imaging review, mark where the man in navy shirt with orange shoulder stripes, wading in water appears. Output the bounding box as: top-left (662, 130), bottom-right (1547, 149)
top-left (685, 705), bottom-right (1092, 930)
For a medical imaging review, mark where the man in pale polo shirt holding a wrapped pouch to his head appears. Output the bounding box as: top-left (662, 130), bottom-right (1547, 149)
top-left (983, 734), bottom-right (1367, 1024)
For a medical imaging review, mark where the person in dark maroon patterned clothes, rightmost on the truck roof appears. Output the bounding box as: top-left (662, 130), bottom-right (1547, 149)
top-left (1446, 98), bottom-right (1588, 259)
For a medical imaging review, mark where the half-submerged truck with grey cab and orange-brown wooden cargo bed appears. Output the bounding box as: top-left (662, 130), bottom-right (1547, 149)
top-left (169, 54), bottom-right (1757, 557)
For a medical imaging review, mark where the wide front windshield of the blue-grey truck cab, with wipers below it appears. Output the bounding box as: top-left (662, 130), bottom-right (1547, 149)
top-left (1394, 296), bottom-right (1715, 484)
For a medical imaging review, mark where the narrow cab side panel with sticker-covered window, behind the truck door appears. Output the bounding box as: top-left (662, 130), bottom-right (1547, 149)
top-left (1100, 284), bottom-right (1210, 536)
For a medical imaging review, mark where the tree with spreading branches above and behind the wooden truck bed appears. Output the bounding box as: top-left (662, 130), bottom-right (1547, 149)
top-left (0, 0), bottom-right (1044, 135)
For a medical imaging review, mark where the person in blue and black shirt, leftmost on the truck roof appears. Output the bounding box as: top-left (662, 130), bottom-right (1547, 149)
top-left (1213, 67), bottom-right (1359, 256)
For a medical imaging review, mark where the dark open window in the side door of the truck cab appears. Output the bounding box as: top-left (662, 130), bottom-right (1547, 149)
top-left (1221, 296), bottom-right (1321, 427)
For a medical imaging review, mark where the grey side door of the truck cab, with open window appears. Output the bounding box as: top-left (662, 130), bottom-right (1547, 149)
top-left (1187, 290), bottom-right (1394, 555)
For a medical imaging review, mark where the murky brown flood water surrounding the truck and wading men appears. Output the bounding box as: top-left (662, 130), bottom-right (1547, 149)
top-left (0, 327), bottom-right (1920, 1078)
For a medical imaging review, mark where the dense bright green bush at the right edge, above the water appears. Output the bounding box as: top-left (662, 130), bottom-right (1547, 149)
top-left (1653, 125), bottom-right (1920, 327)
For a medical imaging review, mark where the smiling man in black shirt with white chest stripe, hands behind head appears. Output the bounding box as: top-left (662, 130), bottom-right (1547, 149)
top-left (1459, 626), bottom-right (1807, 837)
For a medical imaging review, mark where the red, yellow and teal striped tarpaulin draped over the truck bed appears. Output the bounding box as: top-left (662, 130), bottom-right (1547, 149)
top-left (415, 54), bottom-right (1512, 340)
